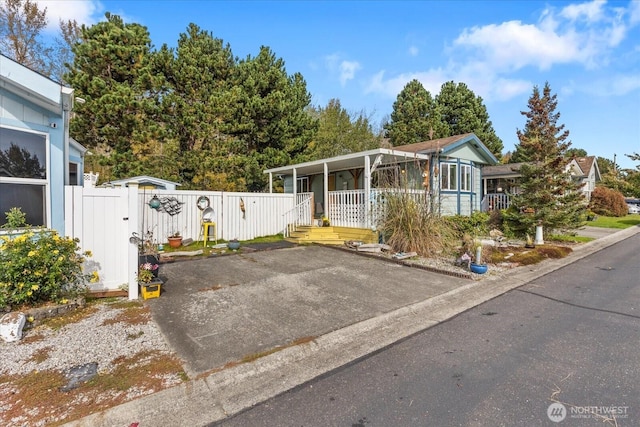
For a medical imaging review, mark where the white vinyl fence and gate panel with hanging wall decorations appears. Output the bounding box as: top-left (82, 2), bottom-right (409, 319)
top-left (65, 184), bottom-right (295, 299)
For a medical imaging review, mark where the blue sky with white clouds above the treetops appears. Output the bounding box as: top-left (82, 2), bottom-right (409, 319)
top-left (38, 0), bottom-right (640, 168)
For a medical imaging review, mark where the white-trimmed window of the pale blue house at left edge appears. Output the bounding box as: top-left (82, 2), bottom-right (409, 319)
top-left (0, 127), bottom-right (48, 226)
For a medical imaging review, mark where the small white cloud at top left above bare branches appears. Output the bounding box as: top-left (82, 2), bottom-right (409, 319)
top-left (35, 0), bottom-right (104, 33)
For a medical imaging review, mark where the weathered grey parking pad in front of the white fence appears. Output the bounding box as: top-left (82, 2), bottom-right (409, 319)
top-left (149, 246), bottom-right (468, 377)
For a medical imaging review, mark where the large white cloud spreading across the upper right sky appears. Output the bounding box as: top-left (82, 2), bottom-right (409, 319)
top-left (365, 0), bottom-right (640, 102)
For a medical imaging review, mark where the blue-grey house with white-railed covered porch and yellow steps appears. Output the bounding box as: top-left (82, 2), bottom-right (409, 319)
top-left (265, 133), bottom-right (497, 232)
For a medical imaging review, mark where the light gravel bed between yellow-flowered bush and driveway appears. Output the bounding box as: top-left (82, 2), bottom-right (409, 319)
top-left (0, 304), bottom-right (172, 375)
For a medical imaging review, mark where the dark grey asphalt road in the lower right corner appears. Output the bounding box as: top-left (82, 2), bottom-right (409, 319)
top-left (216, 235), bottom-right (640, 426)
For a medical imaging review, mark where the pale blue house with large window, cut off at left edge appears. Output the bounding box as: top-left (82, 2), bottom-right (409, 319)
top-left (0, 54), bottom-right (86, 234)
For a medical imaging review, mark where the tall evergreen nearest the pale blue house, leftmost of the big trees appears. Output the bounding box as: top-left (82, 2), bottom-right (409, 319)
top-left (65, 13), bottom-right (159, 178)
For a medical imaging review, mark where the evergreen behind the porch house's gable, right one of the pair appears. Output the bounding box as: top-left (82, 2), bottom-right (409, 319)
top-left (435, 81), bottom-right (504, 159)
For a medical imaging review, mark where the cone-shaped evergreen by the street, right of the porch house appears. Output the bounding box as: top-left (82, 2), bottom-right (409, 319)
top-left (505, 83), bottom-right (586, 235)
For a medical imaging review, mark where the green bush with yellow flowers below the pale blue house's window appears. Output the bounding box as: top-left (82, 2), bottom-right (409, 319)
top-left (0, 230), bottom-right (99, 307)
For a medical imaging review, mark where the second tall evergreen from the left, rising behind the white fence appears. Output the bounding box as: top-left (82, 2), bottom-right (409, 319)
top-left (157, 24), bottom-right (244, 190)
